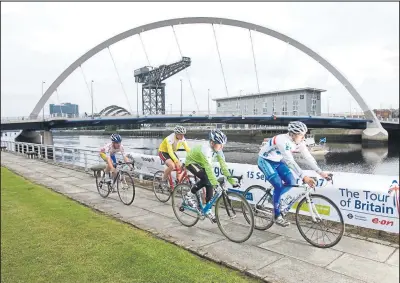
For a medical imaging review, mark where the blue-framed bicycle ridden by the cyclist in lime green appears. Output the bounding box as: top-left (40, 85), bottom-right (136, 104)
top-left (172, 176), bottom-right (254, 243)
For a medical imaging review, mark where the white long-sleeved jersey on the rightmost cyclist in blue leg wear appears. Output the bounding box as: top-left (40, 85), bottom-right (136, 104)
top-left (258, 134), bottom-right (322, 178)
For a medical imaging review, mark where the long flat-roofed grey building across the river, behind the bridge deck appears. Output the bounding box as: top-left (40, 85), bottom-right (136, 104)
top-left (214, 87), bottom-right (326, 116)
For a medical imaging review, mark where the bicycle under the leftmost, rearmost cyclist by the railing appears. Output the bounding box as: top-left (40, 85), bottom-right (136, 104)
top-left (96, 161), bottom-right (135, 205)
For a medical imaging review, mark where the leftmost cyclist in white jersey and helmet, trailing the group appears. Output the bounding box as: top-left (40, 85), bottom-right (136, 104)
top-left (100, 134), bottom-right (130, 183)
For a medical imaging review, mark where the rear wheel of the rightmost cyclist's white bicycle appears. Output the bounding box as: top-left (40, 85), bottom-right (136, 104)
top-left (243, 185), bottom-right (274, 230)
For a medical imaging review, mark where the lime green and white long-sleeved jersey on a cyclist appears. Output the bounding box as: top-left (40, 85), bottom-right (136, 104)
top-left (185, 143), bottom-right (235, 189)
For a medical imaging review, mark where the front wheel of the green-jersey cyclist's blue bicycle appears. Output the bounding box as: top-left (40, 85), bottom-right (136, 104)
top-left (215, 192), bottom-right (254, 243)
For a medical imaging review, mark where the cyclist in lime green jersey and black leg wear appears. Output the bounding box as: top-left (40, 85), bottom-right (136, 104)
top-left (184, 129), bottom-right (236, 222)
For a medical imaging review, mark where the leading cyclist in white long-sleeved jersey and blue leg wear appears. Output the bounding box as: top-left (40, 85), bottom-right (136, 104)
top-left (258, 121), bottom-right (329, 227)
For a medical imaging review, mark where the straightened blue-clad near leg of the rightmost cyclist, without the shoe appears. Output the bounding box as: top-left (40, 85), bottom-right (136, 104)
top-left (258, 157), bottom-right (284, 218)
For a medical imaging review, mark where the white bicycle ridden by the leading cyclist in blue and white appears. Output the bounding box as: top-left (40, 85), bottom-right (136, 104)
top-left (244, 174), bottom-right (345, 248)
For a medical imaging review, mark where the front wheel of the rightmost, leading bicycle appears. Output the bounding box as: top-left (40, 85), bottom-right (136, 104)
top-left (296, 194), bottom-right (345, 248)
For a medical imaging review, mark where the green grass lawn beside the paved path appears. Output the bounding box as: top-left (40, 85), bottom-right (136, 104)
top-left (1, 167), bottom-right (256, 283)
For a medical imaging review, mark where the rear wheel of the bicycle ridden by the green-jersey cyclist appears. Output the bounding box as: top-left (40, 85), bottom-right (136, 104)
top-left (172, 184), bottom-right (200, 227)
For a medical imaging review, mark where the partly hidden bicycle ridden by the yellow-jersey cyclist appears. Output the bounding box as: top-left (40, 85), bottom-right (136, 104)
top-left (153, 164), bottom-right (200, 202)
